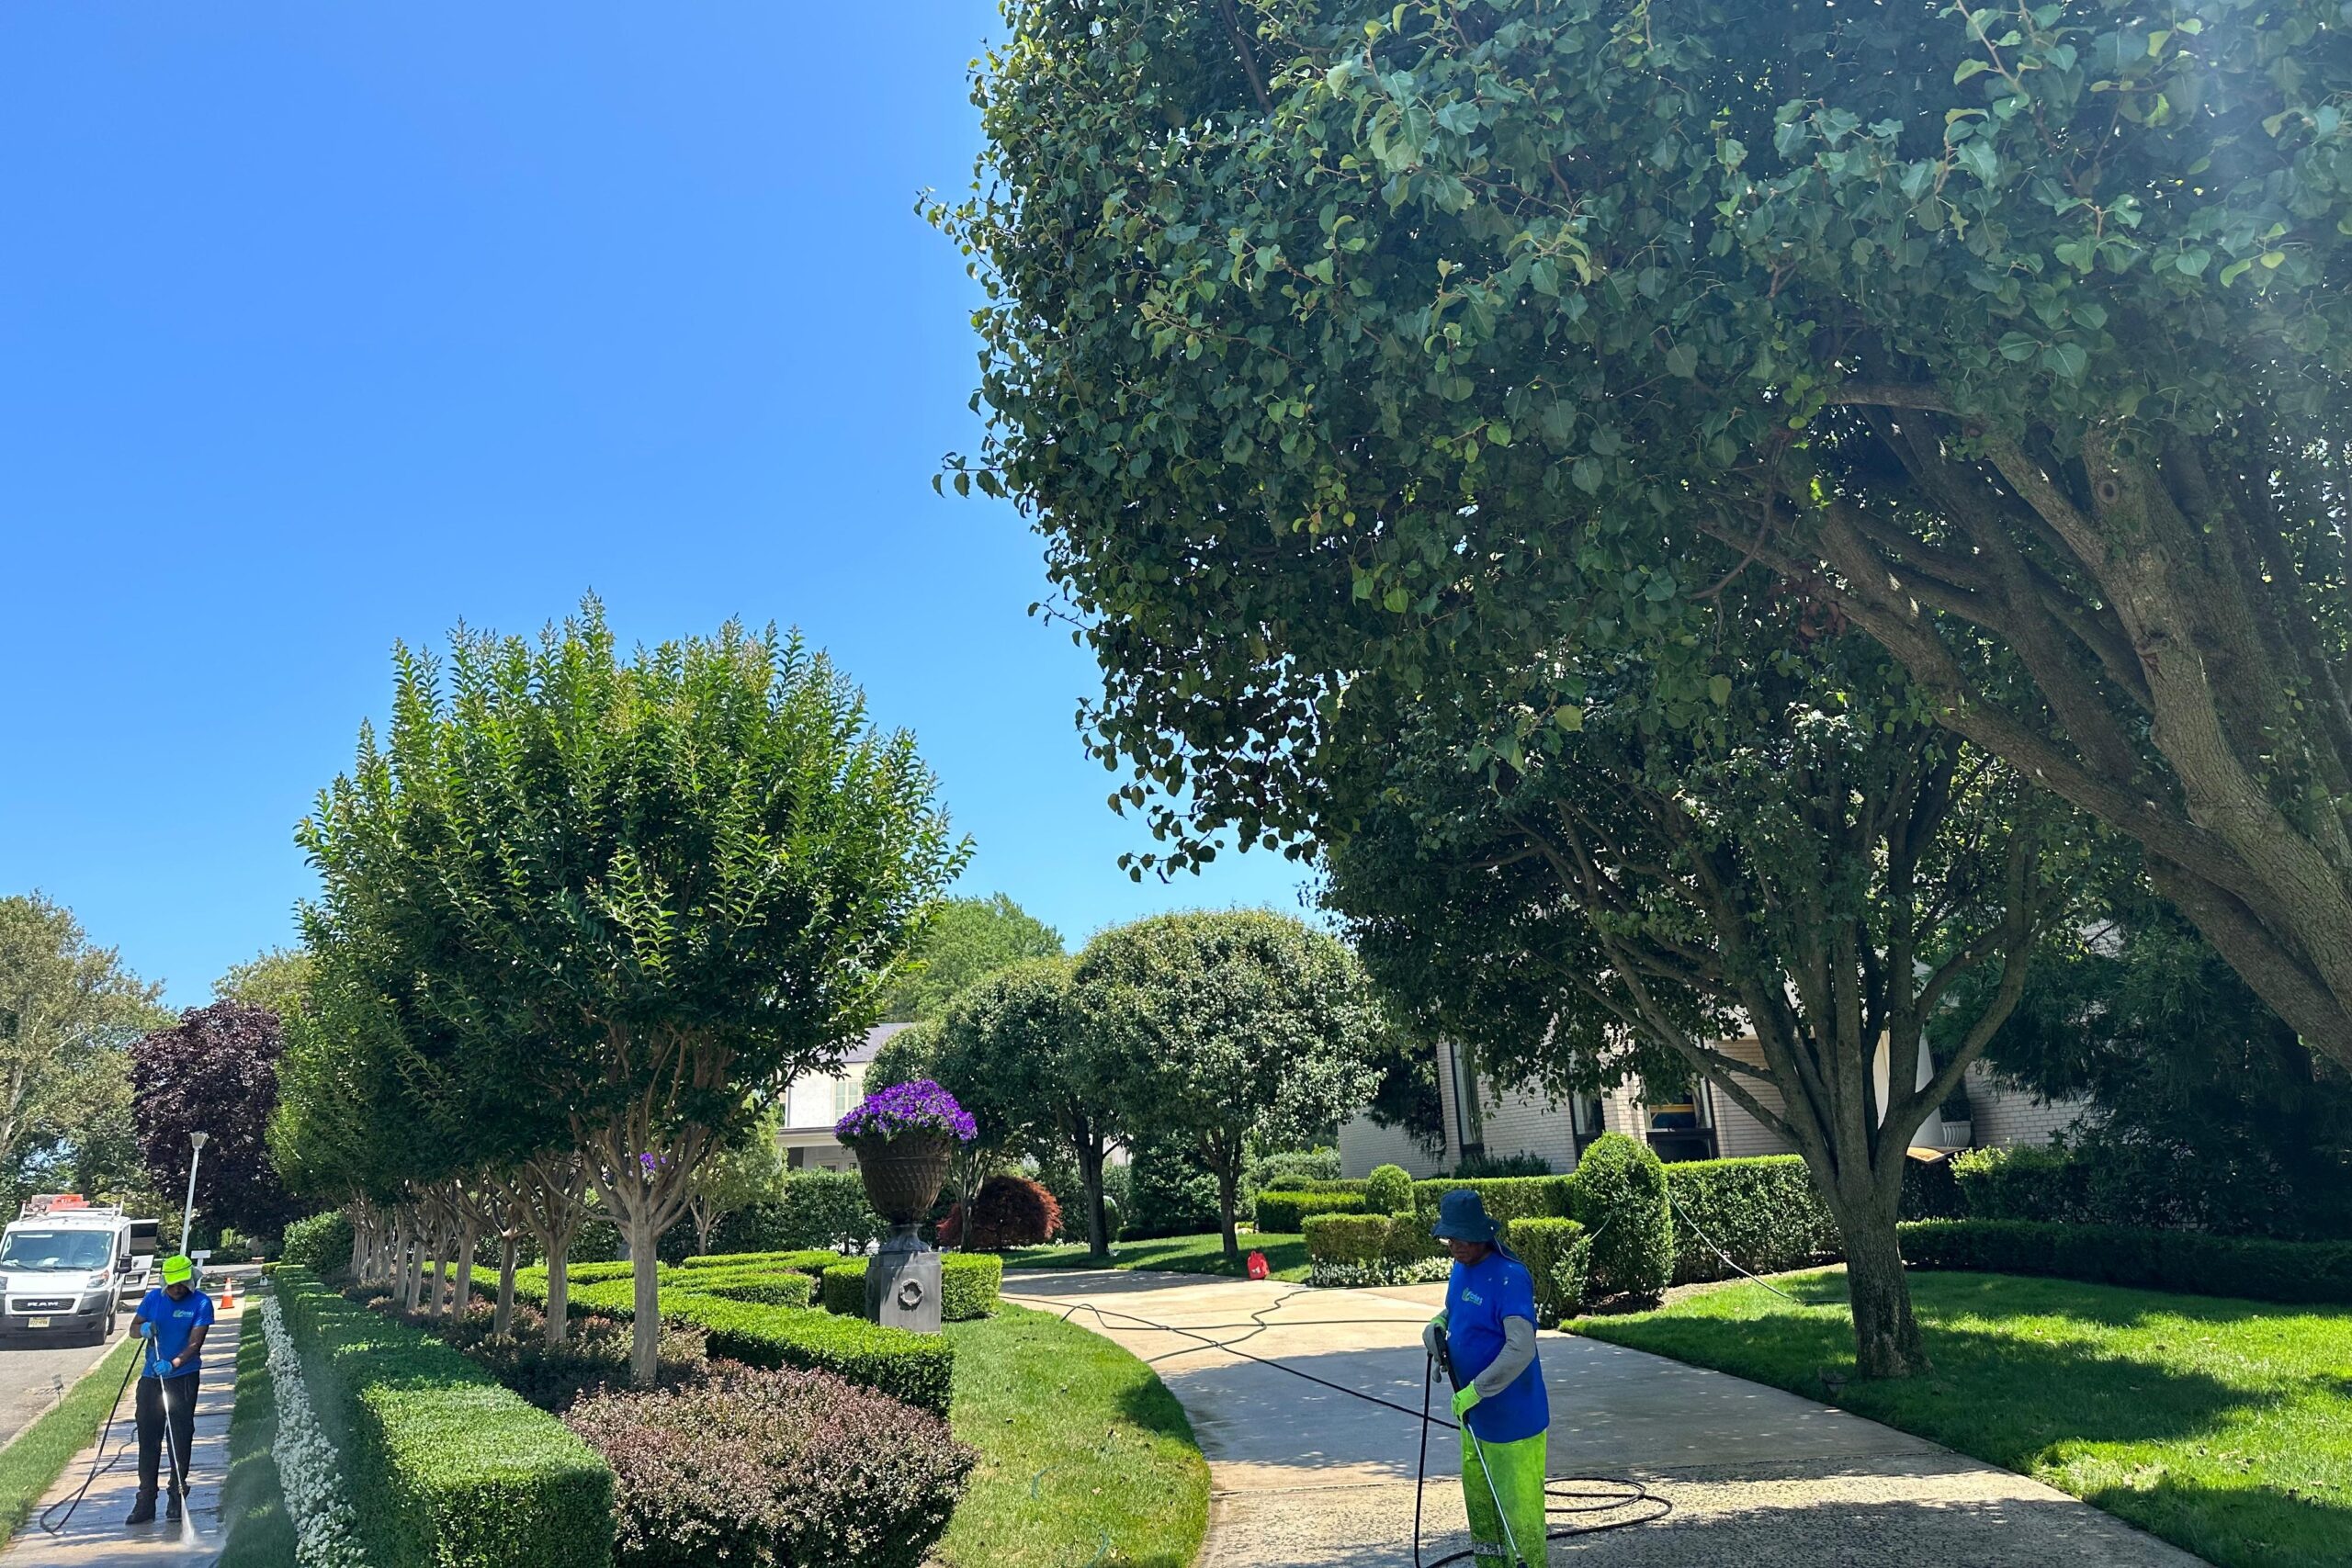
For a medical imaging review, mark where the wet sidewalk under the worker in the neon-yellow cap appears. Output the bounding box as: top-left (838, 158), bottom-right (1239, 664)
top-left (0, 1291), bottom-right (243, 1568)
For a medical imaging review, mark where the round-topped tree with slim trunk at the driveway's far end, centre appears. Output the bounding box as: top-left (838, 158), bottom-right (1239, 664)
top-left (1070, 909), bottom-right (1387, 1260)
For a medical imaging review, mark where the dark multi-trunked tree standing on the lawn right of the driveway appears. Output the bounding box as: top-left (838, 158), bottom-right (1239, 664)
top-left (1327, 637), bottom-right (2079, 1378)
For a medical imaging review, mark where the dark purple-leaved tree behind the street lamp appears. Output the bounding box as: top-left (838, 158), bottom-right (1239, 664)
top-left (131, 999), bottom-right (297, 1236)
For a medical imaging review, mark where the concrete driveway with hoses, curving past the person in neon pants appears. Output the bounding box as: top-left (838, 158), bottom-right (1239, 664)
top-left (1004, 1269), bottom-right (2199, 1568)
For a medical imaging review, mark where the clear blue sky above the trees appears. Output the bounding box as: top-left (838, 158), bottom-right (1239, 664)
top-left (0, 0), bottom-right (1298, 1004)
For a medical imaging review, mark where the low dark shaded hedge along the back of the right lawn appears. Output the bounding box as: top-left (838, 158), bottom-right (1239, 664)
top-left (1898, 1220), bottom-right (2352, 1304)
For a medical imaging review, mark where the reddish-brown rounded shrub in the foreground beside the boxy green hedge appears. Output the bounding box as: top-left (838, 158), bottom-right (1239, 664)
top-left (567, 1371), bottom-right (978, 1568)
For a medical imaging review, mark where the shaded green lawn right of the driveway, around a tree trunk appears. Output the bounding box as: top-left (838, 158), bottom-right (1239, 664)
top-left (1574, 1272), bottom-right (2352, 1568)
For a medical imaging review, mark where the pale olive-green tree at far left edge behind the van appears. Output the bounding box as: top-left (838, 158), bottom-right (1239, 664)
top-left (0, 894), bottom-right (164, 1190)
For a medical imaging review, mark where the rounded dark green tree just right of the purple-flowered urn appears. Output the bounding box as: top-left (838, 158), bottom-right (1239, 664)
top-left (933, 957), bottom-right (1120, 1256)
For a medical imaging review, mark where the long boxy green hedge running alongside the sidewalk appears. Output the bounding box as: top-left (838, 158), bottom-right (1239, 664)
top-left (273, 1267), bottom-right (614, 1568)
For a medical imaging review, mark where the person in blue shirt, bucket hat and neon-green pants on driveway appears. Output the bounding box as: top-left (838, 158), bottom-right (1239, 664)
top-left (1420, 1187), bottom-right (1553, 1568)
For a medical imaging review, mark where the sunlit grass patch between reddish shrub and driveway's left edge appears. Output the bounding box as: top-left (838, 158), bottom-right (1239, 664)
top-left (938, 1307), bottom-right (1209, 1568)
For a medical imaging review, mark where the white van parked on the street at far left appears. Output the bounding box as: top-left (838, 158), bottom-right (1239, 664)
top-left (0, 1194), bottom-right (155, 1345)
